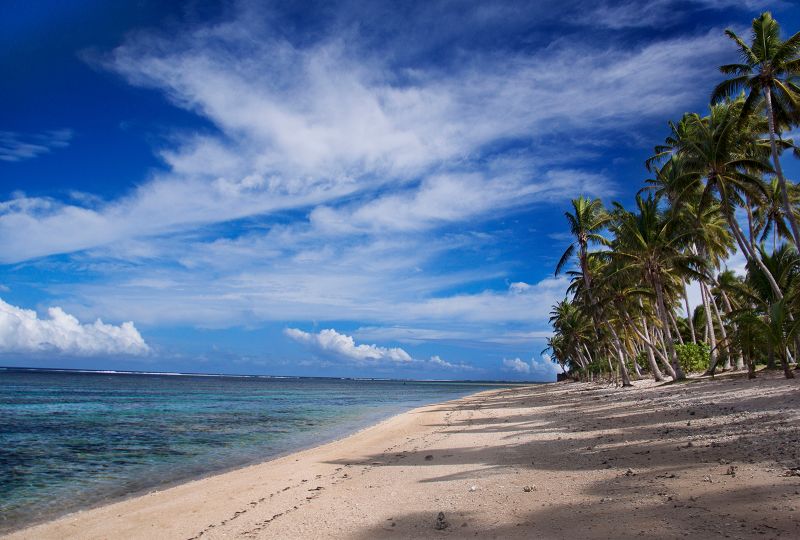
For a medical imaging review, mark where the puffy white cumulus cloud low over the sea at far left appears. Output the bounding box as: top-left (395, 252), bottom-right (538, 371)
top-left (0, 299), bottom-right (150, 356)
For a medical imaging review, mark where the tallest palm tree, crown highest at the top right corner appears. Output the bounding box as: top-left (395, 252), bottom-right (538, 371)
top-left (712, 12), bottom-right (800, 246)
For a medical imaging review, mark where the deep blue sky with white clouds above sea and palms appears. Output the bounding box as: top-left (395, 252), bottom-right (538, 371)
top-left (0, 0), bottom-right (800, 381)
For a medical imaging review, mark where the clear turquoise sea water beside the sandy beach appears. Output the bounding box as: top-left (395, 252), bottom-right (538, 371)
top-left (0, 370), bottom-right (500, 532)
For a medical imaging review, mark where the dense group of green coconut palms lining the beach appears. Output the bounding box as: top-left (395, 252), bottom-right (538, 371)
top-left (545, 12), bottom-right (800, 386)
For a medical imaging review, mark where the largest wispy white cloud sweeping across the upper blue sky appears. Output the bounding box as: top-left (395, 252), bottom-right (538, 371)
top-left (0, 13), bottom-right (730, 262)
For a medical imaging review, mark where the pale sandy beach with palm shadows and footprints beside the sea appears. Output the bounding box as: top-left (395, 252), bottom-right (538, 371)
top-left (9, 374), bottom-right (800, 540)
